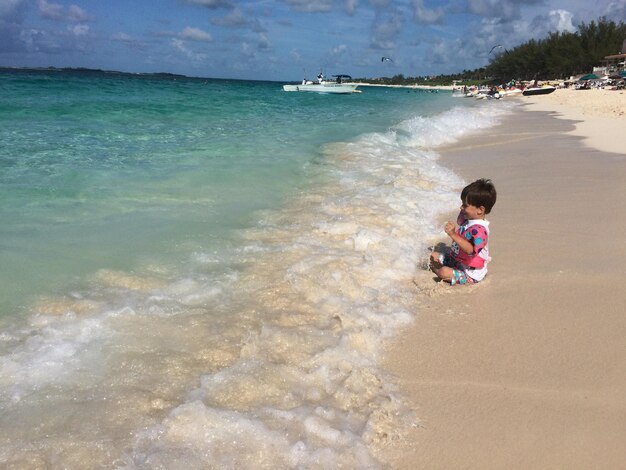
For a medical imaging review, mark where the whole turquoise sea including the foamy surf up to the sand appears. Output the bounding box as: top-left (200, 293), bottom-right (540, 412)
top-left (0, 71), bottom-right (509, 469)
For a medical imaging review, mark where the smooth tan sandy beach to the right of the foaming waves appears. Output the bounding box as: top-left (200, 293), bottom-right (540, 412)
top-left (384, 96), bottom-right (626, 469)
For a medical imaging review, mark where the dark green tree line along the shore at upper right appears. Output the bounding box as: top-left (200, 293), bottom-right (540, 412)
top-left (358, 17), bottom-right (626, 85)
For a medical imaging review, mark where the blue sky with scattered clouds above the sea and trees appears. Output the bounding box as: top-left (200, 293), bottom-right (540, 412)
top-left (0, 0), bottom-right (626, 81)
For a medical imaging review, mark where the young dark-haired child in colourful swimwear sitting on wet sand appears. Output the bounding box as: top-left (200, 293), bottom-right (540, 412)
top-left (430, 179), bottom-right (496, 285)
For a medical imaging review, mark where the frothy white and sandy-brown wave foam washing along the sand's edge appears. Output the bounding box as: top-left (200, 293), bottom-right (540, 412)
top-left (122, 102), bottom-right (504, 468)
